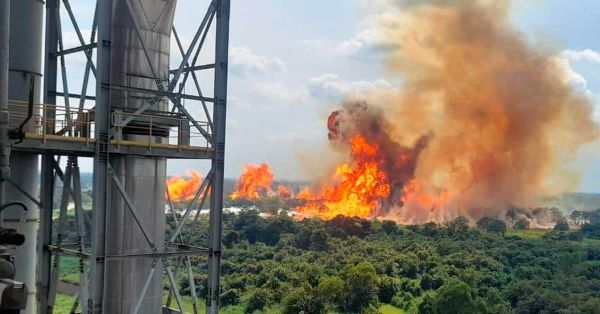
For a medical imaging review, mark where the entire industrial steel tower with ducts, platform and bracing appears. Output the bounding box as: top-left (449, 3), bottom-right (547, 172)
top-left (0, 0), bottom-right (230, 313)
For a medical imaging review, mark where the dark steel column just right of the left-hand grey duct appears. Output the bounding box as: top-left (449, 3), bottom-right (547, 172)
top-left (37, 0), bottom-right (60, 314)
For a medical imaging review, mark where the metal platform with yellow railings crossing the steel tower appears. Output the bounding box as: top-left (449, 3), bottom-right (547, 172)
top-left (9, 101), bottom-right (214, 159)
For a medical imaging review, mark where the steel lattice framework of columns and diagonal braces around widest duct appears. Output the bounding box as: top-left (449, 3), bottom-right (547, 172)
top-left (12, 0), bottom-right (230, 313)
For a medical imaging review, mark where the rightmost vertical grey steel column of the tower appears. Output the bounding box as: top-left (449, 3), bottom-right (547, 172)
top-left (207, 0), bottom-right (230, 314)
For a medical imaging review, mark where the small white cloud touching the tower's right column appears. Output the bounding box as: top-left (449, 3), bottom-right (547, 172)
top-left (229, 46), bottom-right (285, 76)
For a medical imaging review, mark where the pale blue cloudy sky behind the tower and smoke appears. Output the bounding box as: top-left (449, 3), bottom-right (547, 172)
top-left (63, 0), bottom-right (600, 192)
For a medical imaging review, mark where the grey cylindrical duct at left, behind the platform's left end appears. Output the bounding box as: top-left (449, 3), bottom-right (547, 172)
top-left (3, 0), bottom-right (44, 313)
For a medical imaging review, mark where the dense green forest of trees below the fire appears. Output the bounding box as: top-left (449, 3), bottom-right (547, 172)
top-left (54, 210), bottom-right (600, 314)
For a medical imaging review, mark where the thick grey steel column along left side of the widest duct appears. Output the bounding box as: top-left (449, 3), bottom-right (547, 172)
top-left (87, 0), bottom-right (113, 313)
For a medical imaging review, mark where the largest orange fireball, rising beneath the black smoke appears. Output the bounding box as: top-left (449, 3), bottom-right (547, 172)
top-left (296, 135), bottom-right (391, 219)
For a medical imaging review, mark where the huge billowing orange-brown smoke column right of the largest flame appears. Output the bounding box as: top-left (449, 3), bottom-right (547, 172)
top-left (330, 0), bottom-right (598, 223)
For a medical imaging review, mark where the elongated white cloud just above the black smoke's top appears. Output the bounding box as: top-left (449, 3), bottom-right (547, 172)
top-left (306, 73), bottom-right (393, 100)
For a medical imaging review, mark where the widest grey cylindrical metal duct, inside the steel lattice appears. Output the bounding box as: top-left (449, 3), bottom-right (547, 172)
top-left (104, 0), bottom-right (176, 313)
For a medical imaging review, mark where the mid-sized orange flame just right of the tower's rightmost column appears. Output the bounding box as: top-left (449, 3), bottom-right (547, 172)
top-left (229, 163), bottom-right (273, 200)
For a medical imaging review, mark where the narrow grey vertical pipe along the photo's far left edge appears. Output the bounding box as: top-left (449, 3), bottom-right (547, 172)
top-left (0, 0), bottom-right (10, 212)
